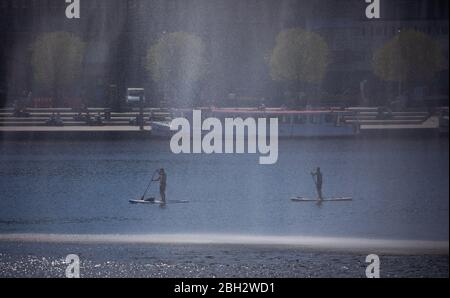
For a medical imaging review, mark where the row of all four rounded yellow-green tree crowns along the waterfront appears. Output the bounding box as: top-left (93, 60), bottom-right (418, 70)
top-left (31, 28), bottom-right (446, 106)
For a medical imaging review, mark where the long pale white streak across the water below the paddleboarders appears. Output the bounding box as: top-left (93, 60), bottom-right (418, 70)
top-left (0, 234), bottom-right (449, 255)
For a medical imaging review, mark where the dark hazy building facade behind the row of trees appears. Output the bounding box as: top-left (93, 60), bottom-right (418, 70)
top-left (0, 0), bottom-right (448, 105)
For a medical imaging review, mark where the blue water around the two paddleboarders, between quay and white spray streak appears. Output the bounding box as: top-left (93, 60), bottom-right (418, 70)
top-left (0, 138), bottom-right (449, 240)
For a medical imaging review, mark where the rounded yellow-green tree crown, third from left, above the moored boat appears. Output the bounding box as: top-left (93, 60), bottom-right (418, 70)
top-left (269, 28), bottom-right (330, 105)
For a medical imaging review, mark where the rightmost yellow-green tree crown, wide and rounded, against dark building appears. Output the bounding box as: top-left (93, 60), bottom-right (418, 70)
top-left (373, 30), bottom-right (445, 94)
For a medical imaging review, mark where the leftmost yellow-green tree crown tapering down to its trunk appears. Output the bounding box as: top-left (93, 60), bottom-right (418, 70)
top-left (31, 32), bottom-right (86, 106)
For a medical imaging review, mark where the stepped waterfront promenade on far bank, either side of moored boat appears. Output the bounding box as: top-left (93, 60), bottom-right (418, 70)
top-left (0, 107), bottom-right (440, 138)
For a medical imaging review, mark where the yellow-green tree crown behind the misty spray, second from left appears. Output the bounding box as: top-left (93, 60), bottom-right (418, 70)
top-left (146, 32), bottom-right (208, 105)
